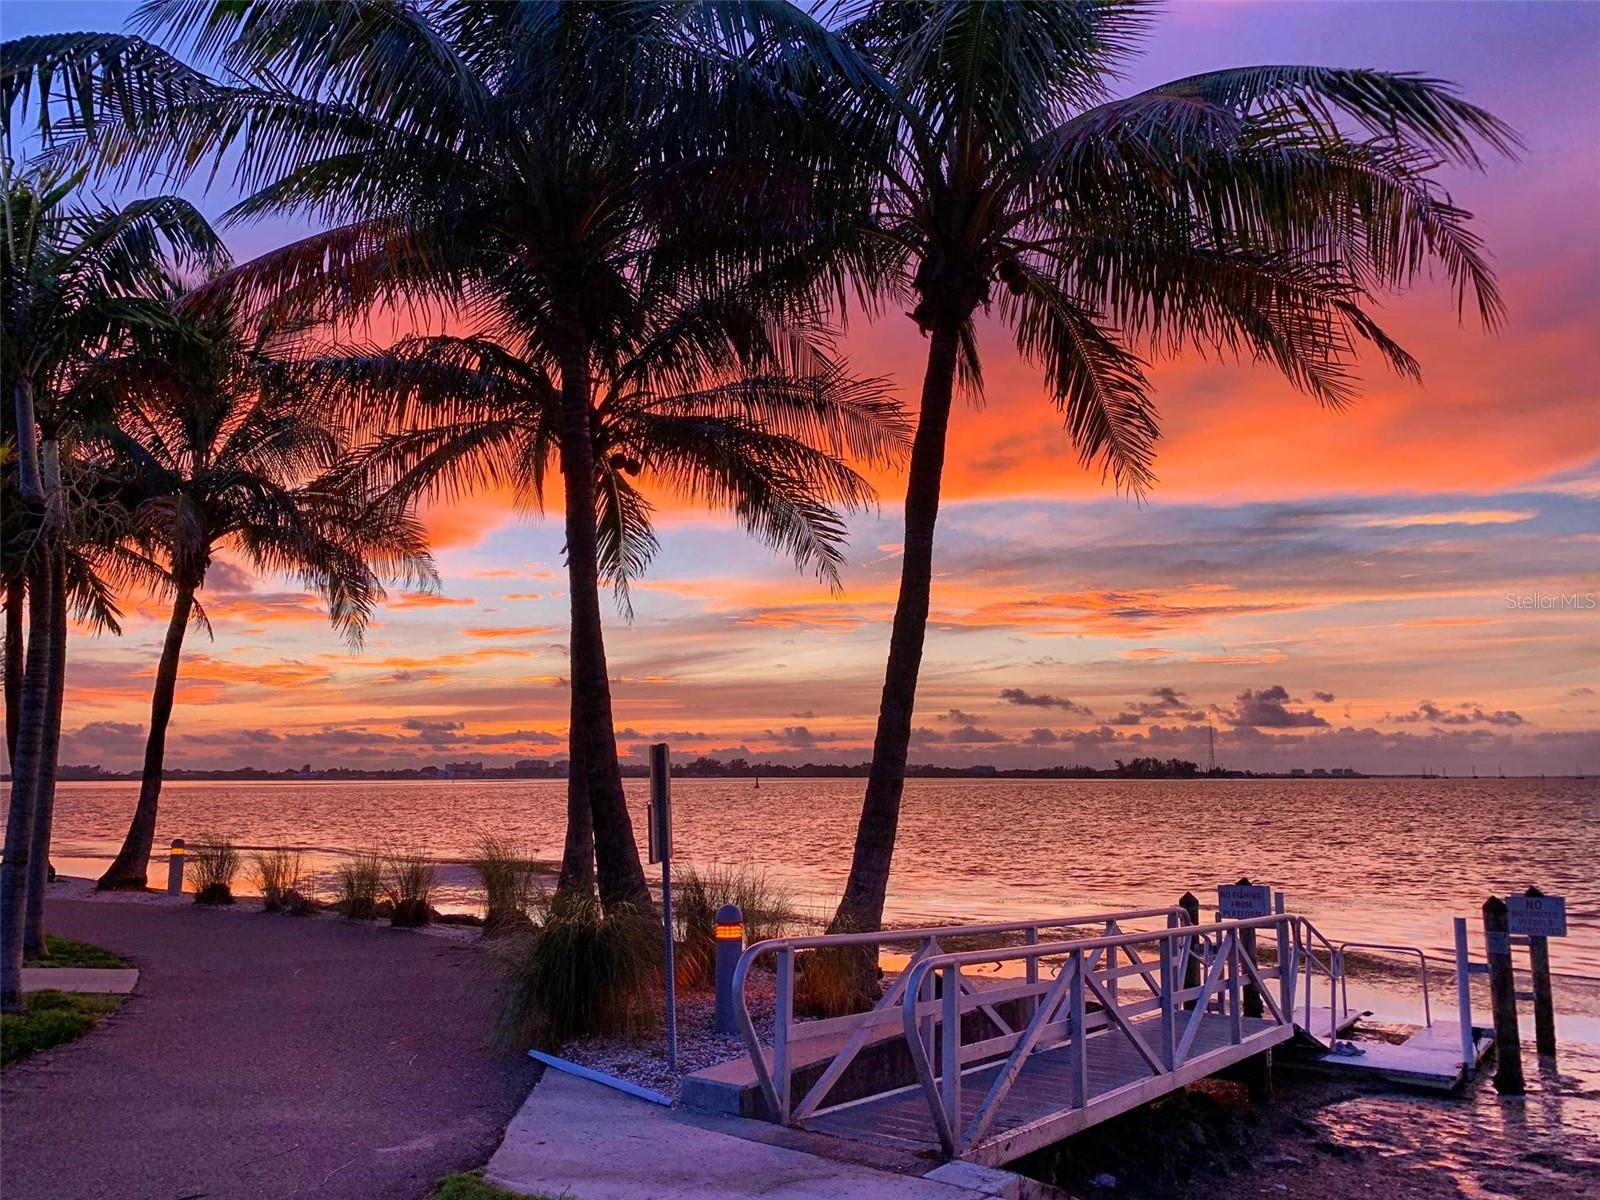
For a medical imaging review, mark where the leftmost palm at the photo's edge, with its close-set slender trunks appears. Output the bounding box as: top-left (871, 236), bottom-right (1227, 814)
top-left (0, 157), bottom-right (222, 1011)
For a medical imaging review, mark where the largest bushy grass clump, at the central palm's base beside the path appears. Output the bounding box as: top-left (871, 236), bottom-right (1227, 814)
top-left (499, 893), bottom-right (661, 1048)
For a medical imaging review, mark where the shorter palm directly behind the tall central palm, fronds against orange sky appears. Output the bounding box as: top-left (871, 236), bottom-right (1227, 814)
top-left (310, 289), bottom-right (904, 891)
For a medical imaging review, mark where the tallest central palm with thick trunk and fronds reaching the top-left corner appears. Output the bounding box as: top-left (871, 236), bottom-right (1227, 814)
top-left (0, 0), bottom-right (876, 907)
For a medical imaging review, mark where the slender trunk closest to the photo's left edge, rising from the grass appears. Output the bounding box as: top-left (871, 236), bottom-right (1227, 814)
top-left (0, 555), bottom-right (53, 1013)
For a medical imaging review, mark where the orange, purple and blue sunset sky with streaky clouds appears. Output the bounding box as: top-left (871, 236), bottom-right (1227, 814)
top-left (0, 0), bottom-right (1600, 774)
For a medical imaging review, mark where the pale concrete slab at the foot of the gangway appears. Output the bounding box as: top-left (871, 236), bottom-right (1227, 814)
top-left (485, 1070), bottom-right (1059, 1200)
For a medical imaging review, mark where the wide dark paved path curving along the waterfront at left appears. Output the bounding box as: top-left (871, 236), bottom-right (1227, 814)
top-left (0, 899), bottom-right (539, 1200)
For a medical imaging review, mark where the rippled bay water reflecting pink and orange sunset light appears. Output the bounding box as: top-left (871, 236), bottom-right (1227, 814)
top-left (56, 779), bottom-right (1600, 979)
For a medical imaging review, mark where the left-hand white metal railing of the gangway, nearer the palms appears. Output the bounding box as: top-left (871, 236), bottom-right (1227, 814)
top-left (733, 906), bottom-right (1189, 1125)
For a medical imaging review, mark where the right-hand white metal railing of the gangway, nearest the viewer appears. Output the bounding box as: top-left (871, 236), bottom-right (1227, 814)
top-left (901, 914), bottom-right (1301, 1155)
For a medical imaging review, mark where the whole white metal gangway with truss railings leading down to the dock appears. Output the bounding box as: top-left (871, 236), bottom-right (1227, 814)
top-left (734, 909), bottom-right (1305, 1166)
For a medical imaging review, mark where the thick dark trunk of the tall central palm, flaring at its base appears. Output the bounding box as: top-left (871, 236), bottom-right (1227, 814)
top-left (562, 333), bottom-right (651, 912)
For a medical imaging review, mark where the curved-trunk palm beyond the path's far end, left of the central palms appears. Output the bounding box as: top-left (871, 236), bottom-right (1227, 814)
top-left (82, 294), bottom-right (434, 888)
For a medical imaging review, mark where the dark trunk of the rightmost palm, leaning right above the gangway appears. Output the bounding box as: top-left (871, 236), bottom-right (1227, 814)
top-left (830, 325), bottom-right (960, 931)
